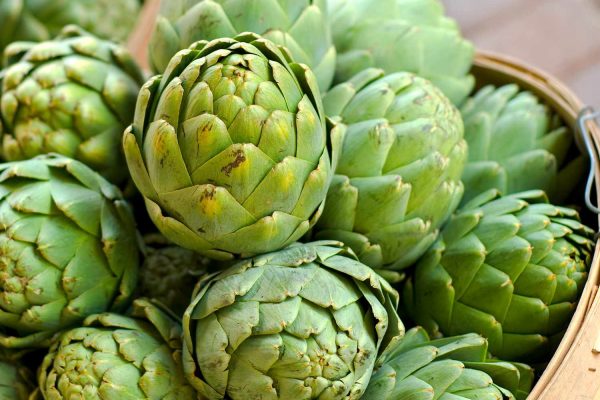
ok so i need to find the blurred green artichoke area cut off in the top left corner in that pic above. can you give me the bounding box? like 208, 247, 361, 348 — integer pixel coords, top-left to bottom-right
0, 0, 140, 53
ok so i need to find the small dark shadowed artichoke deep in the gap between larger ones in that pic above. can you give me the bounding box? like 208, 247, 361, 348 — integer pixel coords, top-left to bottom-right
140, 235, 211, 315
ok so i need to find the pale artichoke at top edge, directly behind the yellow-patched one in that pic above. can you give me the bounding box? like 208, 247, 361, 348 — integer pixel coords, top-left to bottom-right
149, 0, 335, 90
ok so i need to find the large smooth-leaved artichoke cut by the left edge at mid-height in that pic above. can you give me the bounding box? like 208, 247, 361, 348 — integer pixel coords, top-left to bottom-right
0, 156, 139, 348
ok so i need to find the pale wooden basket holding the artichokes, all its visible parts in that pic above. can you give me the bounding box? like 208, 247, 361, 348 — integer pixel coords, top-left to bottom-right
129, 0, 600, 400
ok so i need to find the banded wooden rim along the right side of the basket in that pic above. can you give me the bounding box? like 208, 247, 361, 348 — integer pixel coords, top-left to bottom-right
472, 51, 600, 400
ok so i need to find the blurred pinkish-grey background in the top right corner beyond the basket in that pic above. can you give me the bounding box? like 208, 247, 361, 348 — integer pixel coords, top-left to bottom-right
442, 0, 600, 109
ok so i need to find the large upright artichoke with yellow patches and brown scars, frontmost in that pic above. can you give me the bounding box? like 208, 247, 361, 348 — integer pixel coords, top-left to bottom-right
123, 34, 343, 259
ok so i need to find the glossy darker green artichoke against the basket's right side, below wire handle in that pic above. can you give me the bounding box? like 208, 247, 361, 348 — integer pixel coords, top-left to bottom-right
402, 190, 594, 362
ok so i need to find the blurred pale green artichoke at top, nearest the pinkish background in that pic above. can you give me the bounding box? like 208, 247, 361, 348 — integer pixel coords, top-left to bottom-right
329, 0, 475, 104
